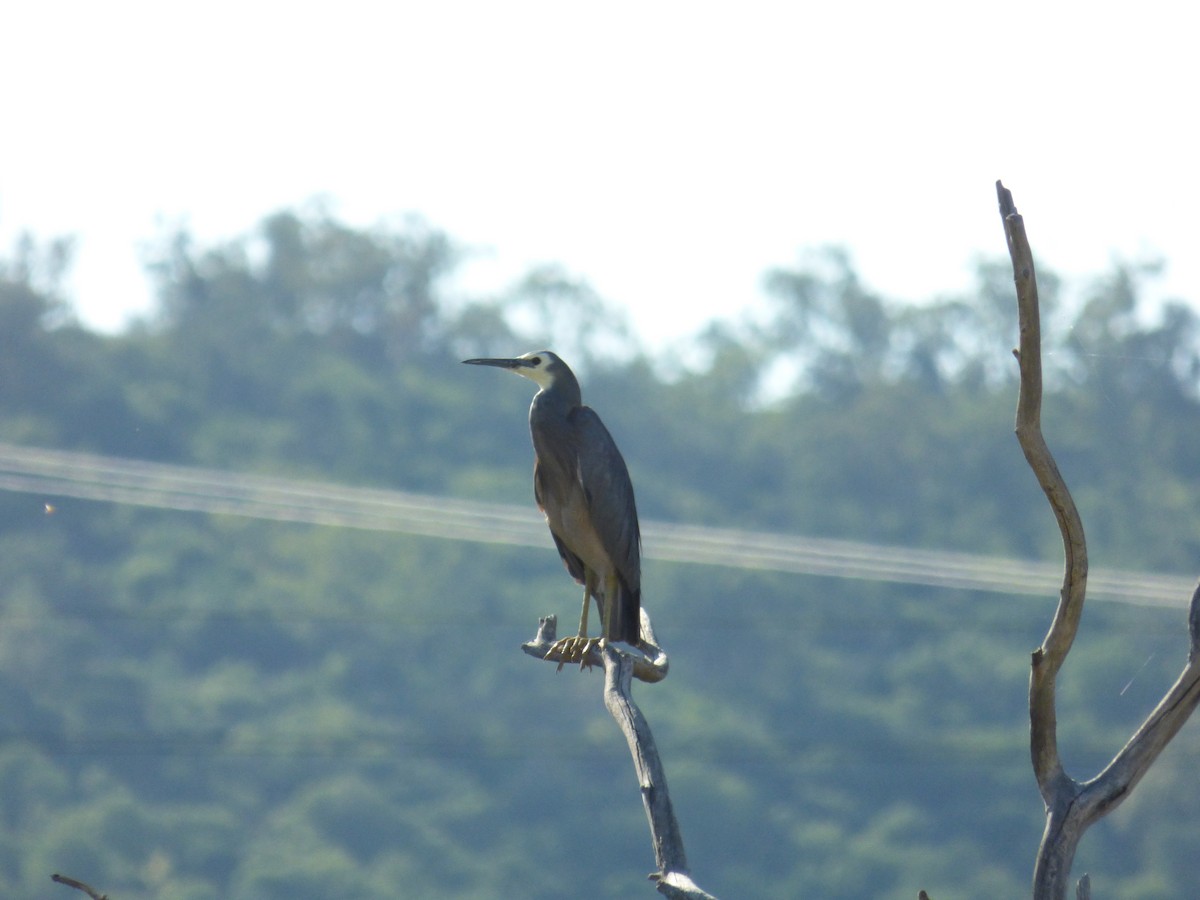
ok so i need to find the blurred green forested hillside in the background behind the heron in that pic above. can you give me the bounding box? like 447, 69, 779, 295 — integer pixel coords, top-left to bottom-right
0, 209, 1200, 900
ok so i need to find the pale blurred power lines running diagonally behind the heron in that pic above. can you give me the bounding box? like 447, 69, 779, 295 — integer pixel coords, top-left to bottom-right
0, 443, 1195, 608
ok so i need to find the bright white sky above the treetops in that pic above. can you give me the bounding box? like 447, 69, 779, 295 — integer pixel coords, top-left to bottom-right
0, 0, 1200, 349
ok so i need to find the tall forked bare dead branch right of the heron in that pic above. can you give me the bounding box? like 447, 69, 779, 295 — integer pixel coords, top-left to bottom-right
996, 181, 1200, 900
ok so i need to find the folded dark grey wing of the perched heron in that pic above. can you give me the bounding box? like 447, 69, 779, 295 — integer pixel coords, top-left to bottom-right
570, 407, 642, 594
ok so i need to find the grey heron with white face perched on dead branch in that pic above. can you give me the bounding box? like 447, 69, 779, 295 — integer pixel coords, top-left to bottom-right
463, 350, 642, 668
